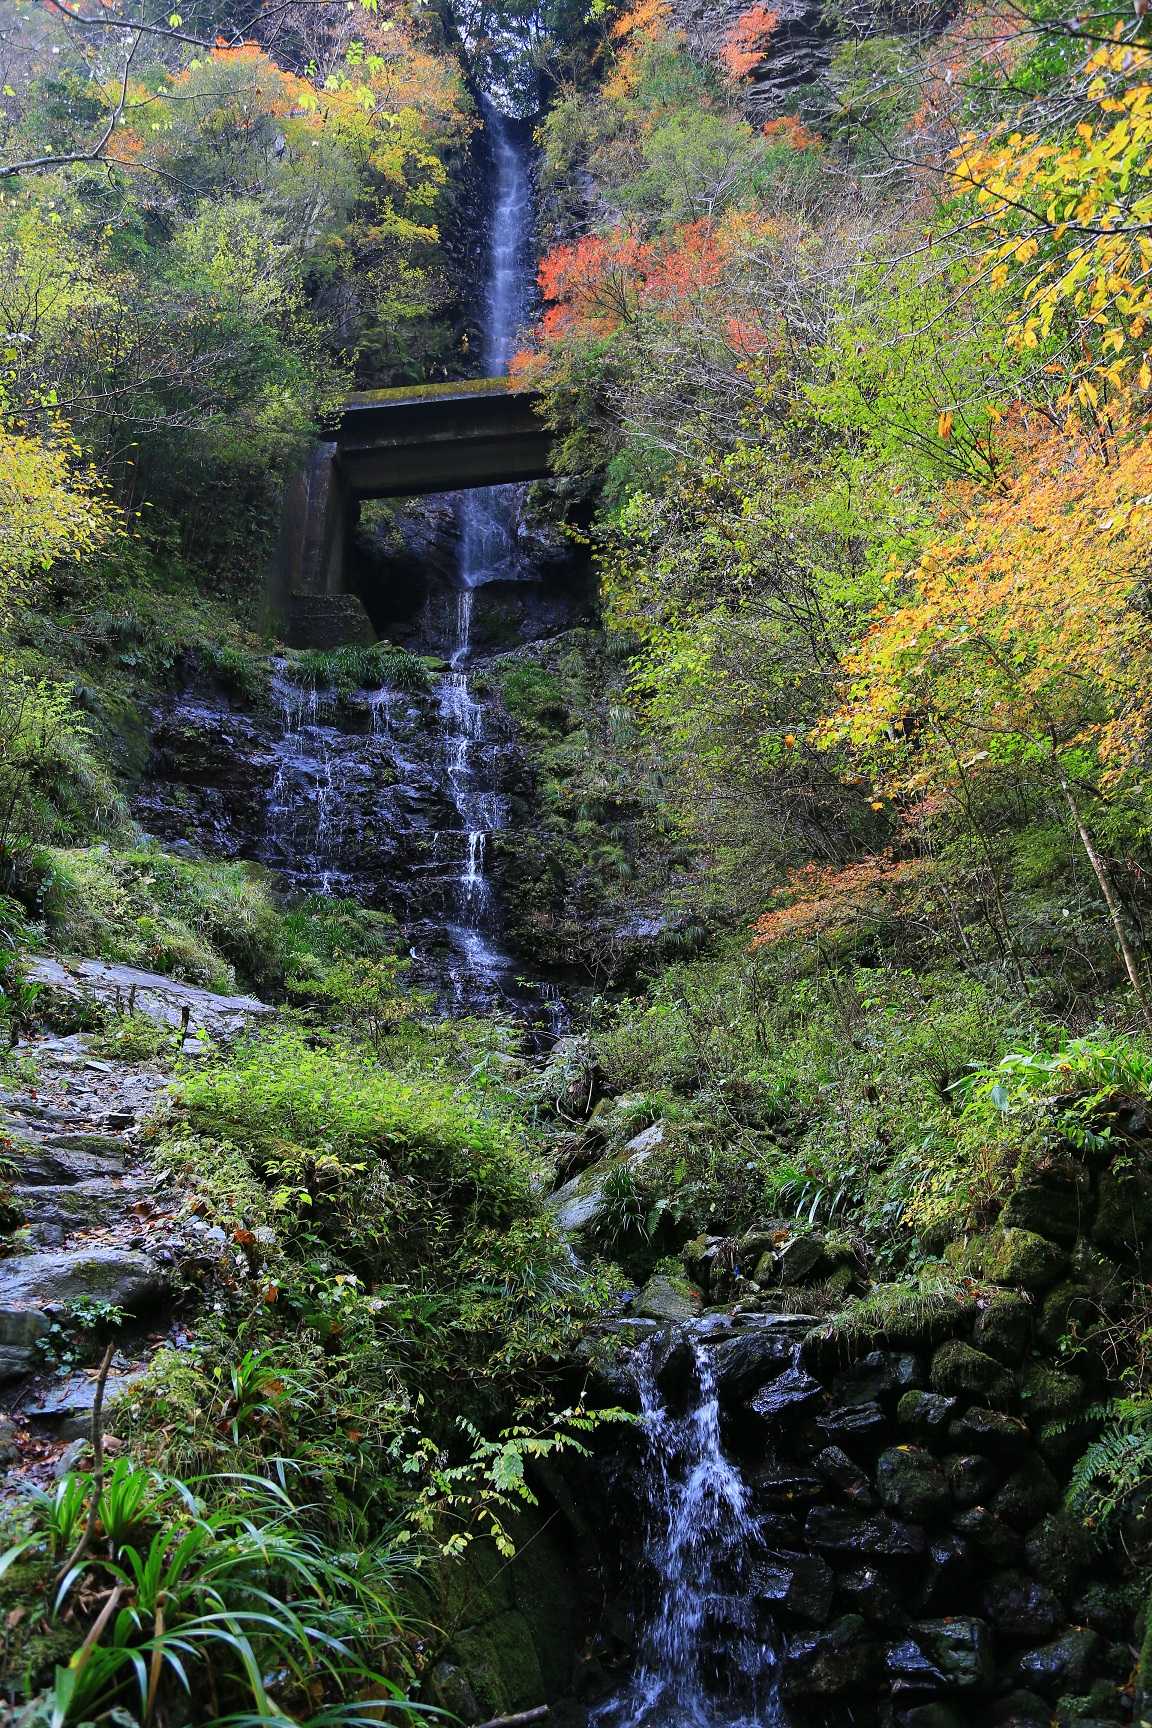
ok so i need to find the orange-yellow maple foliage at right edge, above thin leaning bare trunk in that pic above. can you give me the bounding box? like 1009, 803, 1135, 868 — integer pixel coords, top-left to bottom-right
817, 400, 1152, 788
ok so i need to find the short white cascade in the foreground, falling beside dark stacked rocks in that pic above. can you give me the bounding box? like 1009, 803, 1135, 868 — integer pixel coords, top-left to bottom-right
594, 1337, 784, 1728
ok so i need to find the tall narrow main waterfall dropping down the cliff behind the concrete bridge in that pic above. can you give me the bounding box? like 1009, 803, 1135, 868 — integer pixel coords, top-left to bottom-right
440, 107, 532, 999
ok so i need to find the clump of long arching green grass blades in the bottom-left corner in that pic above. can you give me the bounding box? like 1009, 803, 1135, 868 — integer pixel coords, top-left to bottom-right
0, 1458, 419, 1728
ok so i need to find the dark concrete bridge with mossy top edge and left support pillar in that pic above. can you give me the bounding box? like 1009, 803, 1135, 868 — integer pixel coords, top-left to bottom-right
275, 378, 551, 628
